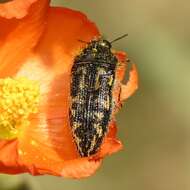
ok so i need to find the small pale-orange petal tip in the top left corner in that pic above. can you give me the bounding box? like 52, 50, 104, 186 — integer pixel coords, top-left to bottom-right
0, 0, 37, 19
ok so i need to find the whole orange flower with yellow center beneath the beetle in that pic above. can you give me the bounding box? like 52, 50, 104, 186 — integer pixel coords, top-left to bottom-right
0, 0, 138, 178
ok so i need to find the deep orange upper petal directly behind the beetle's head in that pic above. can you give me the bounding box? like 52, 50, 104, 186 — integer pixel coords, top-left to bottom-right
37, 8, 99, 68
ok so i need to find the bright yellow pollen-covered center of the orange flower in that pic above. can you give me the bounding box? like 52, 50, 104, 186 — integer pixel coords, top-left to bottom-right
0, 77, 40, 140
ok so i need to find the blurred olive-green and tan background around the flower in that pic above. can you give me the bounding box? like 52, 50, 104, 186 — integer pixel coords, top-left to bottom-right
0, 0, 190, 190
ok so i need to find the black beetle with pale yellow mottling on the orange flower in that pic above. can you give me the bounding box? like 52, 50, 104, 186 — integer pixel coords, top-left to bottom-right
69, 35, 126, 157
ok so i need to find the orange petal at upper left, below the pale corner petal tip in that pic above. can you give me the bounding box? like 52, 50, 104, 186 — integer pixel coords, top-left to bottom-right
0, 0, 49, 78
